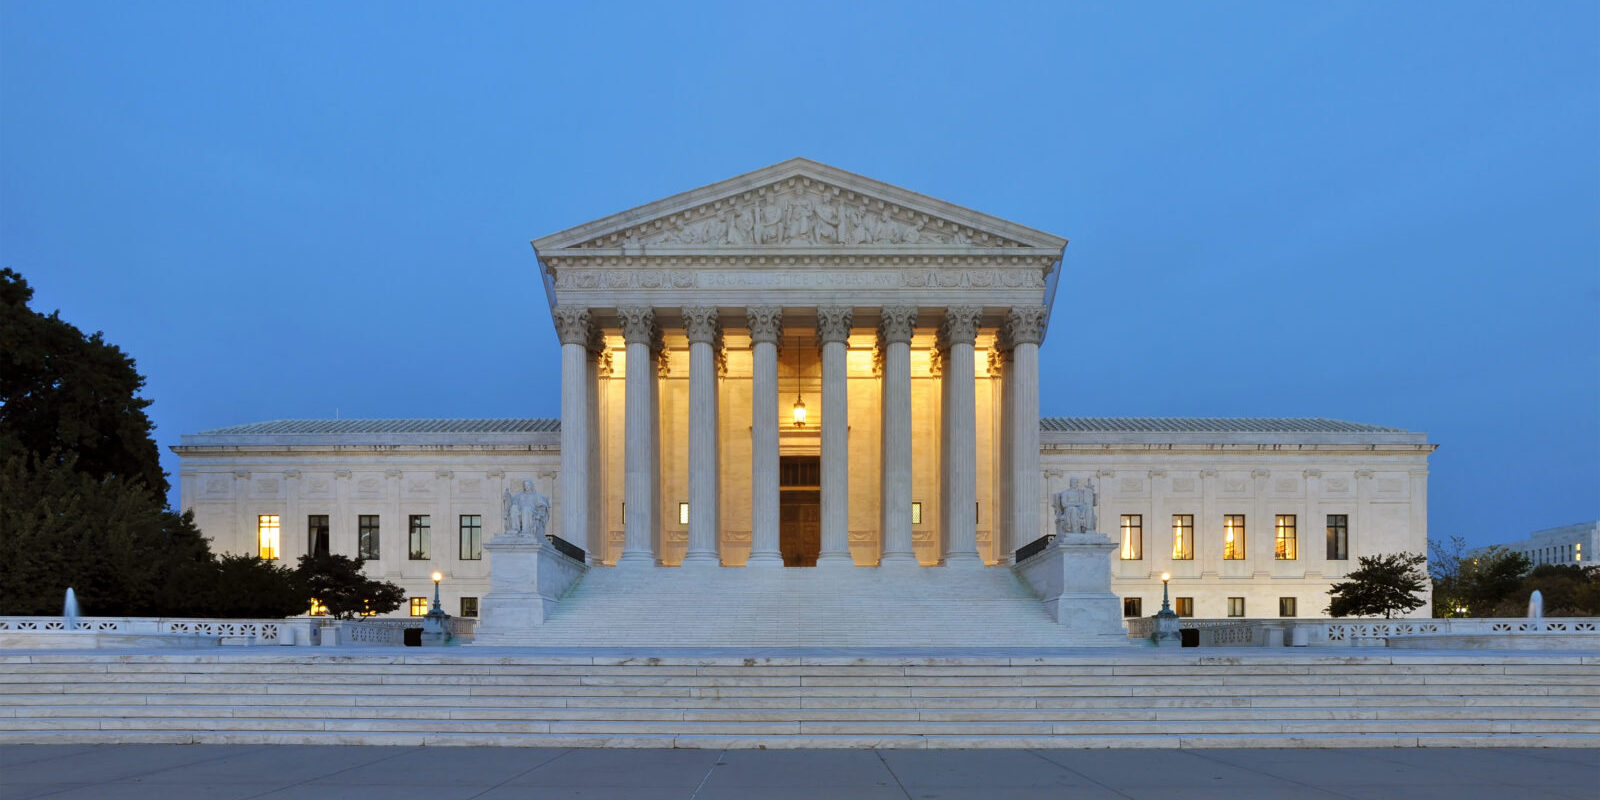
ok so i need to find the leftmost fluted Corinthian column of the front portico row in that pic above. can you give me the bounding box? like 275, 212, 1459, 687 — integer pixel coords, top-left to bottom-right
550, 306, 594, 547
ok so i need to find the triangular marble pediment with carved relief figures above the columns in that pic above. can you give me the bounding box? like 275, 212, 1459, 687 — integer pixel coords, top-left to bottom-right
533, 158, 1067, 254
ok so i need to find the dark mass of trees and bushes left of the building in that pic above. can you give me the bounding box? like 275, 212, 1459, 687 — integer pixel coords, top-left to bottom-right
0, 269, 310, 618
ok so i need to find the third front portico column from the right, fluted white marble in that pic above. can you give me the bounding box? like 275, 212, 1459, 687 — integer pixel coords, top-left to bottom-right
878, 306, 917, 566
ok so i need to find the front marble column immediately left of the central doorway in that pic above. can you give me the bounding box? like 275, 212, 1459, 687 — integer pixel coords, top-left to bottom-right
744, 306, 784, 566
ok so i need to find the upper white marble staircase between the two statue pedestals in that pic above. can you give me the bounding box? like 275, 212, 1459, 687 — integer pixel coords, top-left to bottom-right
530, 566, 1066, 648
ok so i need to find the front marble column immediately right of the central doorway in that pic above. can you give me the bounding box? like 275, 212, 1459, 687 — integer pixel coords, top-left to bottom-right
816, 306, 854, 566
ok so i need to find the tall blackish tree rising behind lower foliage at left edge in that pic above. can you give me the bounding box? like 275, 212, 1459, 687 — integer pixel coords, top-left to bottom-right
0, 269, 168, 498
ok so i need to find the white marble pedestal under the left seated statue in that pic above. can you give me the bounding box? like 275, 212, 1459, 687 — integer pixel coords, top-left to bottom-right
474, 536, 589, 646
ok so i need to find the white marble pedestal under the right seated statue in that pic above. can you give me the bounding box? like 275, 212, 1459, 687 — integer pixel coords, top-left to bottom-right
1013, 533, 1130, 646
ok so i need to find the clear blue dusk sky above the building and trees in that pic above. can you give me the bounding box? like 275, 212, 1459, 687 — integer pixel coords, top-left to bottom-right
0, 0, 1600, 544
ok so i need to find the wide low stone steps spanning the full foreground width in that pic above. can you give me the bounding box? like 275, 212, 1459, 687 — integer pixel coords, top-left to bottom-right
0, 649, 1600, 747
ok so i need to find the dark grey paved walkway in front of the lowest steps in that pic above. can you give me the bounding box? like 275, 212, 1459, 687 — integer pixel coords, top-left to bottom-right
0, 744, 1600, 800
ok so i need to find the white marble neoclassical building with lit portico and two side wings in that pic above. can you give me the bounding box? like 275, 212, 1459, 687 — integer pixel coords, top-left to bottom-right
174, 158, 1434, 640
